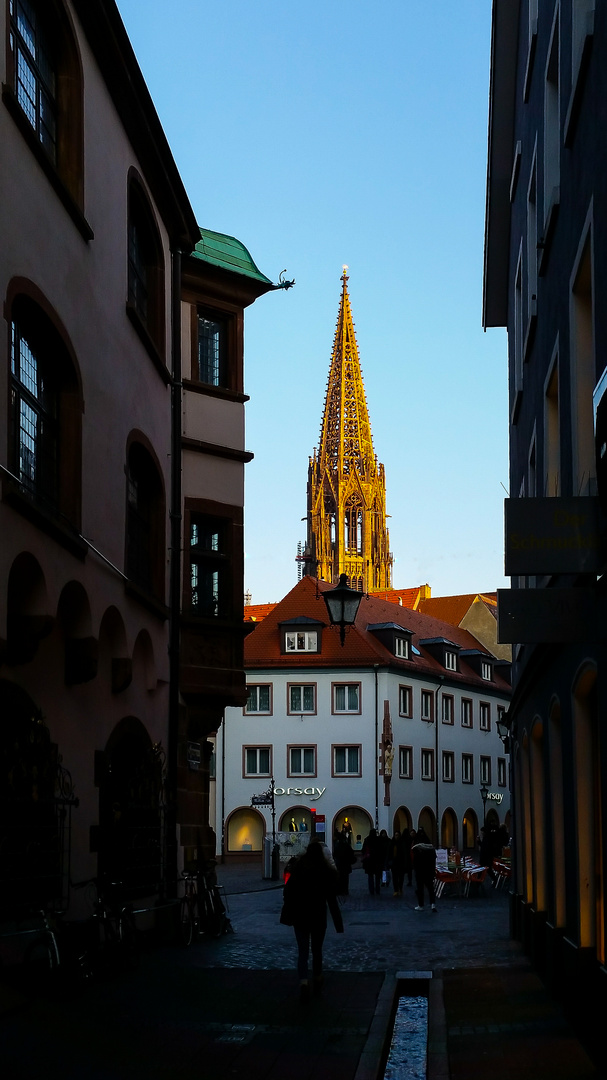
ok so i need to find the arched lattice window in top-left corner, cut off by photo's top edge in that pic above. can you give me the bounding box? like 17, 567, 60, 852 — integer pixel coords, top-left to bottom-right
3, 0, 85, 212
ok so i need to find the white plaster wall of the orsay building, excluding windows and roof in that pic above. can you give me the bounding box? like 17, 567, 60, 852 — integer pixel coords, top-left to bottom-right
216, 670, 510, 845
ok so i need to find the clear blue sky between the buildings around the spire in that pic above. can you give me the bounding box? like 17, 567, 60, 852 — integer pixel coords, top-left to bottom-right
118, 0, 508, 604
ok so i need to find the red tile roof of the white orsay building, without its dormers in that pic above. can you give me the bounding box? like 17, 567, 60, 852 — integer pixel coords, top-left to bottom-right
244, 577, 510, 693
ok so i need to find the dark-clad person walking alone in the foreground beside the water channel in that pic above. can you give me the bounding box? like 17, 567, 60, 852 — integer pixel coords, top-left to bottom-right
281, 840, 343, 1001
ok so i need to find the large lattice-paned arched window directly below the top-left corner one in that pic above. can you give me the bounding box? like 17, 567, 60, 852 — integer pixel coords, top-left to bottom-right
9, 285, 82, 528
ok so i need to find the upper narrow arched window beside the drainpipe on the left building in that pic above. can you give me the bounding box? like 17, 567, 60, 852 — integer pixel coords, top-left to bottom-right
126, 178, 165, 357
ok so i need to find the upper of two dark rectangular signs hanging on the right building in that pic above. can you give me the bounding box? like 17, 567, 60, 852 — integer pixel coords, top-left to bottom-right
504, 496, 604, 577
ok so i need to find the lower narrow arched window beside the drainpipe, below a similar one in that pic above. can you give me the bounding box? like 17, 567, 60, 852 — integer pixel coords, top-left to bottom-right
126, 442, 164, 599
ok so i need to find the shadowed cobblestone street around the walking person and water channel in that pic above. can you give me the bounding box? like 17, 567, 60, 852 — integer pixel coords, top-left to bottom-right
0, 866, 598, 1080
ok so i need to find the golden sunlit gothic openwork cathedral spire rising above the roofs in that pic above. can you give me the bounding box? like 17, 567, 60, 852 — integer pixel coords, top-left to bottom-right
305, 267, 392, 593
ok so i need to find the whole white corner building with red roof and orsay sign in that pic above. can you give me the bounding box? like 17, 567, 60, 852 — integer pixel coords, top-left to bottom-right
215, 578, 510, 859
